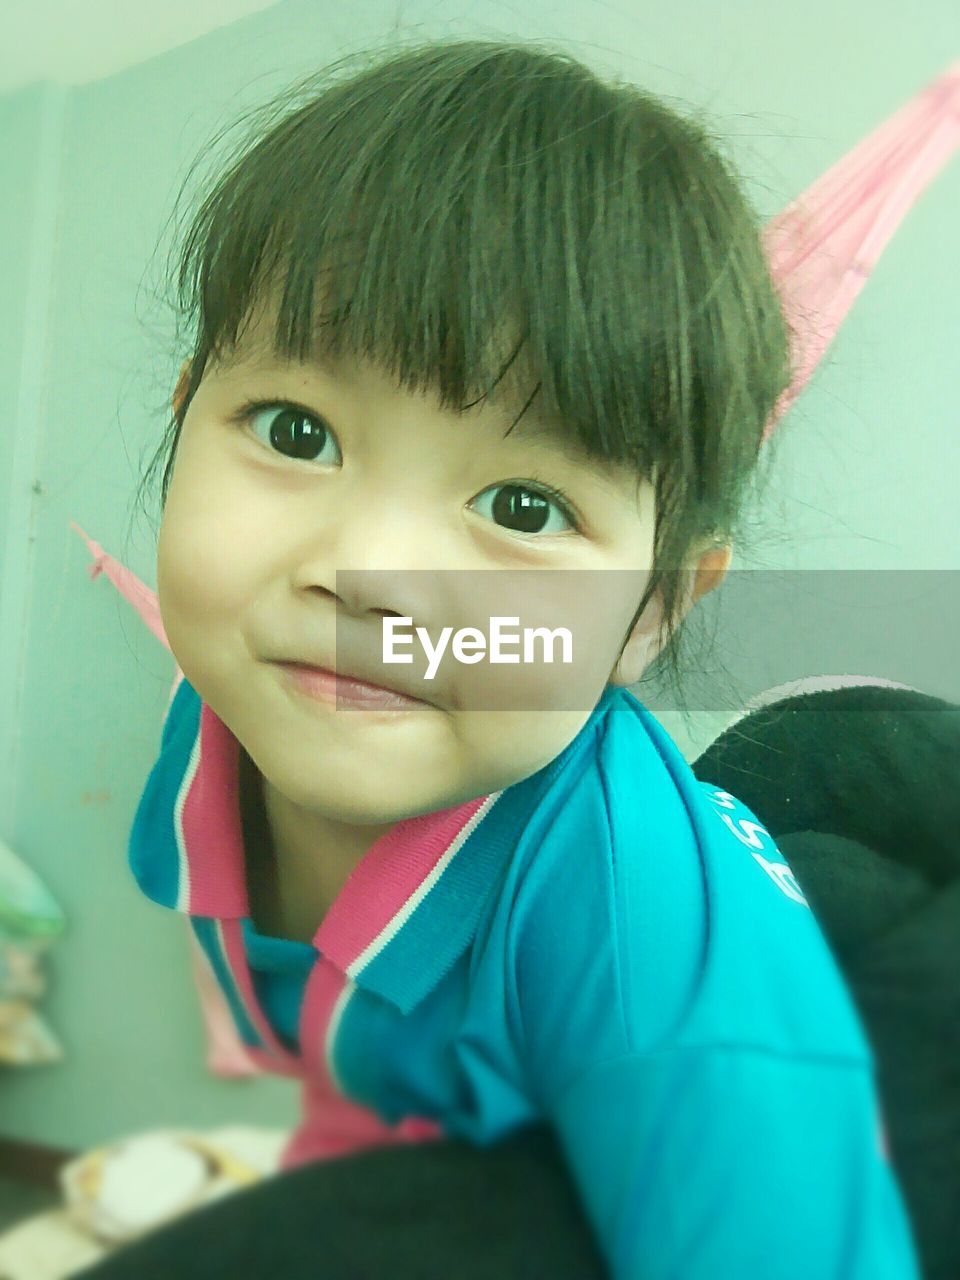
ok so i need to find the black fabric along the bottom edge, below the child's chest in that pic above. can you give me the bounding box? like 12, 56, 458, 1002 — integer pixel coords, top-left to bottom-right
77, 1126, 608, 1280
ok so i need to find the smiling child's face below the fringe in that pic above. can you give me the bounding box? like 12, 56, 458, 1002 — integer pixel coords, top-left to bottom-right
157, 294, 722, 824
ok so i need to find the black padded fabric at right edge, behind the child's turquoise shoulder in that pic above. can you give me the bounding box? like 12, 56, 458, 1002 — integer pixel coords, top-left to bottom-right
694, 686, 960, 1280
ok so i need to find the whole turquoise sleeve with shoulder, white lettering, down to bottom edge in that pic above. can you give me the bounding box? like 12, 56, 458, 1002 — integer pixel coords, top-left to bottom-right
511, 709, 918, 1280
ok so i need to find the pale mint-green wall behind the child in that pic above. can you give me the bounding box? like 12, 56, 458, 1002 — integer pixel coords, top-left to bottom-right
0, 0, 960, 1147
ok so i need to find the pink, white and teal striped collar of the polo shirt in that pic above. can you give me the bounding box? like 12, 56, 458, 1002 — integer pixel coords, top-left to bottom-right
129, 677, 616, 1012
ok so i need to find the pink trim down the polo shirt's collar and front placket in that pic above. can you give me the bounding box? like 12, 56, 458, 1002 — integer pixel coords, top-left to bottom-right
163, 686, 471, 1167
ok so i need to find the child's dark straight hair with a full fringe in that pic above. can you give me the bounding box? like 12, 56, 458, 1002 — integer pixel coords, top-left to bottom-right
141, 40, 791, 727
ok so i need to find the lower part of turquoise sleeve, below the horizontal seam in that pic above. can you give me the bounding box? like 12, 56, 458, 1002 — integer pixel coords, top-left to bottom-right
548, 1047, 919, 1280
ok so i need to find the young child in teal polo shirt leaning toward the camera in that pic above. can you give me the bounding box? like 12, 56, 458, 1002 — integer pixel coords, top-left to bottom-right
122, 42, 916, 1280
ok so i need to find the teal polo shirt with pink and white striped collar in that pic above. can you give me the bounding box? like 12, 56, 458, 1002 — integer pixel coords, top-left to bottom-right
124, 680, 918, 1280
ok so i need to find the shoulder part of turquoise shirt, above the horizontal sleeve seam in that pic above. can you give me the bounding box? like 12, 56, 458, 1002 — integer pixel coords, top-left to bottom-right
509, 690, 869, 1061
